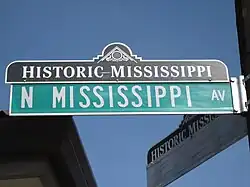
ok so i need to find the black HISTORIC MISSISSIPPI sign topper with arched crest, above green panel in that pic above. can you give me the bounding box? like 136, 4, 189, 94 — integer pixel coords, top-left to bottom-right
5, 42, 229, 84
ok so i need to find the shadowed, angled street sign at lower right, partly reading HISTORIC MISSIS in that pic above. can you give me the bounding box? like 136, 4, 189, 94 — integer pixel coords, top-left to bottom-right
147, 114, 247, 187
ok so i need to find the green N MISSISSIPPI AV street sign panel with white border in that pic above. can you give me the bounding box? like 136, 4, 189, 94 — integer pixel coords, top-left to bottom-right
10, 82, 234, 116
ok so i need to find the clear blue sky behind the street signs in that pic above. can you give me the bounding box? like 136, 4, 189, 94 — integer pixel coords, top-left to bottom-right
0, 0, 250, 187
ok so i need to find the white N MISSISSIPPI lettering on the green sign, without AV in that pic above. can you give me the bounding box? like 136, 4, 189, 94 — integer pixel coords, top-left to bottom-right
20, 84, 192, 109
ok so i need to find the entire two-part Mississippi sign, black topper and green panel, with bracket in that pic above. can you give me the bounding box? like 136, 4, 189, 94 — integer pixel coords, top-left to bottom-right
5, 42, 246, 115
